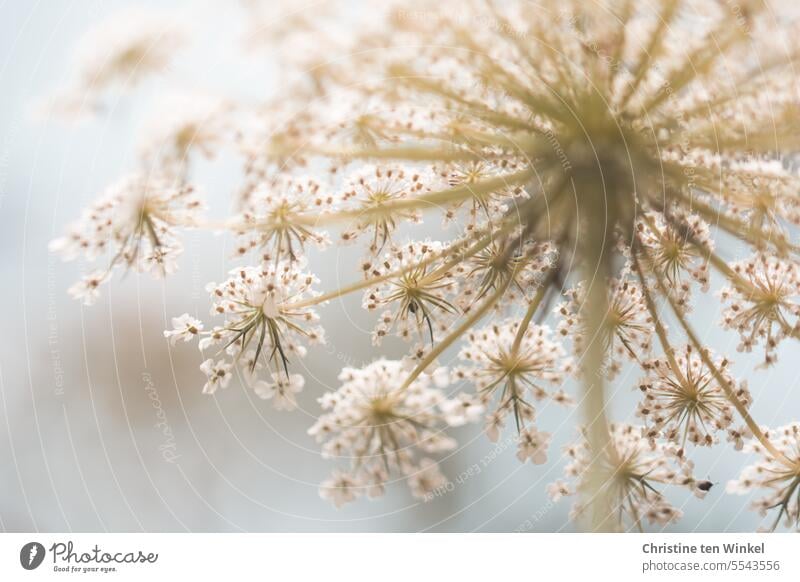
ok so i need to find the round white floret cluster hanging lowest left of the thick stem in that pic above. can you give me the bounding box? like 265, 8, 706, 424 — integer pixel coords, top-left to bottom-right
309, 359, 472, 505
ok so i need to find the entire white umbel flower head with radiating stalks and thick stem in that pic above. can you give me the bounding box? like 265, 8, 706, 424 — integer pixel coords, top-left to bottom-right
45, 0, 800, 530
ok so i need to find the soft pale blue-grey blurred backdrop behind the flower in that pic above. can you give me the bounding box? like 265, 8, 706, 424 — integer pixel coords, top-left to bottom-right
0, 0, 800, 532
